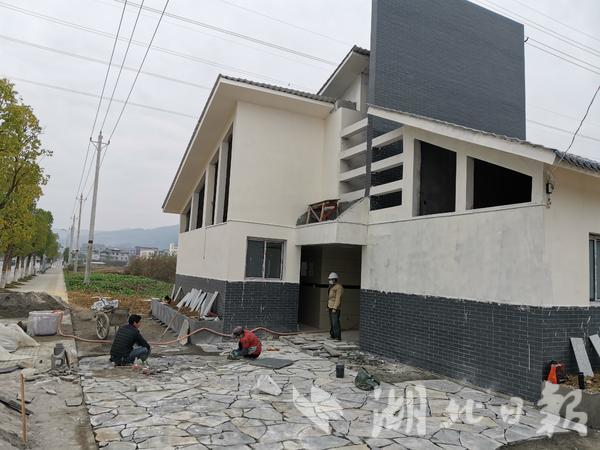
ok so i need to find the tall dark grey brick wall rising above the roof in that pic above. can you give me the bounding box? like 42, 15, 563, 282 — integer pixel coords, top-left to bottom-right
369, 0, 525, 139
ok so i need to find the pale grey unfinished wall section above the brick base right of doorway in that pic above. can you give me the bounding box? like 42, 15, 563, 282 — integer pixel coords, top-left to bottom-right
362, 206, 552, 305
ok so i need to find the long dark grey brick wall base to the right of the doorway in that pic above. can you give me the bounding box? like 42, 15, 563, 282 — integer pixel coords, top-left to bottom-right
360, 290, 600, 400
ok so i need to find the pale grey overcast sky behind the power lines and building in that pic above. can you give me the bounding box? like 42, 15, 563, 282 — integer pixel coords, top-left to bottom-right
0, 0, 600, 230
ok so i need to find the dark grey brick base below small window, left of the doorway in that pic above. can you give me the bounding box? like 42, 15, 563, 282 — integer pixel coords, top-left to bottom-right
175, 275, 300, 332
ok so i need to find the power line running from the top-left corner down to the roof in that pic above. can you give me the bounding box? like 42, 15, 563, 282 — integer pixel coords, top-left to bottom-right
0, 2, 310, 90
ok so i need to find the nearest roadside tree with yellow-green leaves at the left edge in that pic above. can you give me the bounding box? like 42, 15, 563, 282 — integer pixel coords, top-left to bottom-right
0, 79, 52, 287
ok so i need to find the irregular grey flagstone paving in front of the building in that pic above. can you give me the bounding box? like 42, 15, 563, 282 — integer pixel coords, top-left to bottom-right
80, 341, 573, 450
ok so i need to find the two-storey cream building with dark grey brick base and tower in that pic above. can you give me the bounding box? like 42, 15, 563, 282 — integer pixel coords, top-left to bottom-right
163, 0, 600, 399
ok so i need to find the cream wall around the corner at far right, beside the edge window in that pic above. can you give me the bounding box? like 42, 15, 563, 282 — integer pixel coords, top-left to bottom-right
545, 168, 600, 305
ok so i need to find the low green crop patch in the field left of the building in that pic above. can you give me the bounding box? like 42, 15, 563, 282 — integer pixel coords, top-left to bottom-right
65, 271, 172, 298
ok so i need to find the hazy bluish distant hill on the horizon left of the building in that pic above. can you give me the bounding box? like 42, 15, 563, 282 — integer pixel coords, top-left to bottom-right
54, 225, 179, 250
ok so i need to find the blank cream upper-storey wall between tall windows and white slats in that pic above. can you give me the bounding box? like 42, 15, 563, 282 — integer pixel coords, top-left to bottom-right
229, 102, 325, 225
